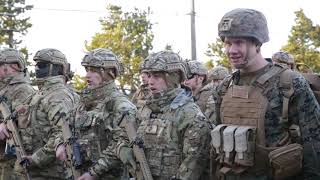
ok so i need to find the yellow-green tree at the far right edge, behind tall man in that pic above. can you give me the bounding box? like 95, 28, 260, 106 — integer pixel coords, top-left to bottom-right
281, 9, 320, 72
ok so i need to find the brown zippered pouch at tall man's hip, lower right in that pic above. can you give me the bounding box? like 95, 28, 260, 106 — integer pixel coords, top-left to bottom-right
269, 143, 303, 180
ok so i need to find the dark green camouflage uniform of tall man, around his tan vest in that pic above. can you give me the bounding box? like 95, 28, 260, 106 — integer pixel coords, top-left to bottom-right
214, 64, 320, 180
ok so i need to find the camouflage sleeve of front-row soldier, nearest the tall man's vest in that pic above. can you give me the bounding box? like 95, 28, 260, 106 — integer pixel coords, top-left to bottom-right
177, 104, 209, 180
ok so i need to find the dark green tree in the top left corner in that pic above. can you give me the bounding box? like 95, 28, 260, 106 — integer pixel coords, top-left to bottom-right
0, 0, 33, 48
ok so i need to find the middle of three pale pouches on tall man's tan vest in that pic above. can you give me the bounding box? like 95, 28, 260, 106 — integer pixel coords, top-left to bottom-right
223, 126, 238, 165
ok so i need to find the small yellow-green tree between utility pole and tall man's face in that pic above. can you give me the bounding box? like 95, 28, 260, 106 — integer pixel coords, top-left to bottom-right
205, 38, 231, 69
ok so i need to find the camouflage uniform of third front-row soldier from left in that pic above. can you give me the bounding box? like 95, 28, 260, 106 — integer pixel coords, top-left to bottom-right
70, 81, 136, 179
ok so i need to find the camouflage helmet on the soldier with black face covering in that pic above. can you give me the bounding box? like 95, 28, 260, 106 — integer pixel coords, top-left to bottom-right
33, 48, 70, 75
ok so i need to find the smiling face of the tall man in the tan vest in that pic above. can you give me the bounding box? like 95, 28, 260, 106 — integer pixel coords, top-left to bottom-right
224, 37, 257, 69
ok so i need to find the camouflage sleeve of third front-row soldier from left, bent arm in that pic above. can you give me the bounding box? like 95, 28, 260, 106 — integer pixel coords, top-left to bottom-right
90, 97, 137, 177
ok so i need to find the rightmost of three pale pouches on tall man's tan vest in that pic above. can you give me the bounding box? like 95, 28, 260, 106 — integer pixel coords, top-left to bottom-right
235, 126, 256, 167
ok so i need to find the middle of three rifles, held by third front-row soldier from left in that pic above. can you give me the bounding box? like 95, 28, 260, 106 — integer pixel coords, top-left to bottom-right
60, 113, 82, 180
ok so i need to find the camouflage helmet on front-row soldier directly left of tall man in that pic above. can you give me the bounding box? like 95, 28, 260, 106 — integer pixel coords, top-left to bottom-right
140, 51, 187, 81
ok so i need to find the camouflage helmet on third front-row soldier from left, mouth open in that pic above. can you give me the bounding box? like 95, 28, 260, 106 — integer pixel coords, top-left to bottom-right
81, 48, 123, 76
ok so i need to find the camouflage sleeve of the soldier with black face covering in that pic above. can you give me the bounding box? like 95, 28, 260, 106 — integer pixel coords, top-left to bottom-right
32, 91, 73, 165
